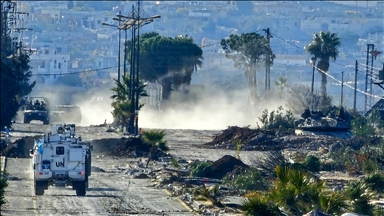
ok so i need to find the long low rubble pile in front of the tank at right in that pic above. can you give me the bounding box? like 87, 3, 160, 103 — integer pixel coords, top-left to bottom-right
202, 126, 341, 151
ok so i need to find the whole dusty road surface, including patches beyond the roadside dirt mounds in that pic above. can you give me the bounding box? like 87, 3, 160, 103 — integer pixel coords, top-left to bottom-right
2, 123, 258, 216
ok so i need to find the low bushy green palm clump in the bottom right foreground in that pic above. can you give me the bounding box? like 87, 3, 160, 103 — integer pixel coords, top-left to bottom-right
242, 165, 348, 215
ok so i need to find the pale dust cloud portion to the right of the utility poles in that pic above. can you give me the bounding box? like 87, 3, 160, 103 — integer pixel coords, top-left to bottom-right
139, 89, 282, 130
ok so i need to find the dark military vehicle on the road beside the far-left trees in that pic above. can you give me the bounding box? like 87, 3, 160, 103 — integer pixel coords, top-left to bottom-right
23, 97, 50, 125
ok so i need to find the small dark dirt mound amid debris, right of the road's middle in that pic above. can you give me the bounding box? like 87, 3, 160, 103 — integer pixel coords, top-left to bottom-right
207, 155, 248, 179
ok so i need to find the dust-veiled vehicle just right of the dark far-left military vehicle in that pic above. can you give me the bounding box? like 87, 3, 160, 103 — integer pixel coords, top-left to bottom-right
51, 105, 81, 123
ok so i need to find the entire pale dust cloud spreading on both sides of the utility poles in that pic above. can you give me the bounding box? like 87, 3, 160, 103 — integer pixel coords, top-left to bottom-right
31, 83, 283, 130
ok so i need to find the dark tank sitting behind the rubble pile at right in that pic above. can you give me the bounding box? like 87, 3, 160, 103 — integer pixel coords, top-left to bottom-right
295, 109, 351, 132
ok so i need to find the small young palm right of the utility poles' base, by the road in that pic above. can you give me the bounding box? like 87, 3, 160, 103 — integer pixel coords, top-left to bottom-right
143, 130, 169, 167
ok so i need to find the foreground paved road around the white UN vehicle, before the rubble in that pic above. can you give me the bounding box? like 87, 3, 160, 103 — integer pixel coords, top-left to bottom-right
1, 158, 191, 216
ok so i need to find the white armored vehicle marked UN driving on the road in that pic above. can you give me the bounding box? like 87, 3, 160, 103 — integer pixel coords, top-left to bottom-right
30, 124, 93, 196
